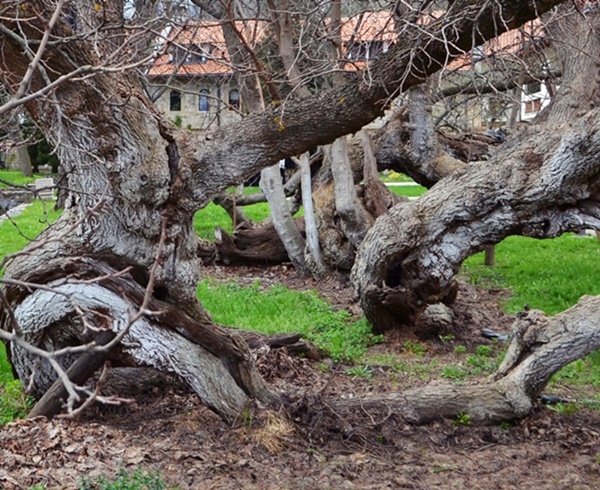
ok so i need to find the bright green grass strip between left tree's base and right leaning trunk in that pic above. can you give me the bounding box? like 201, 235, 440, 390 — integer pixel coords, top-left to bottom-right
198, 280, 380, 360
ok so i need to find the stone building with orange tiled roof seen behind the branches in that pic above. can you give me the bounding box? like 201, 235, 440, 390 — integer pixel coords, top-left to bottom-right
147, 11, 550, 129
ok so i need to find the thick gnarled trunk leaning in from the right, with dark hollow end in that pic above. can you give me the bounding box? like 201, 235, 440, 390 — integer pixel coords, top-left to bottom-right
352, 3, 600, 332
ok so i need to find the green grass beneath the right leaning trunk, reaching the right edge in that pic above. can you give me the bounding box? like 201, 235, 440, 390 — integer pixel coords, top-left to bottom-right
462, 233, 600, 315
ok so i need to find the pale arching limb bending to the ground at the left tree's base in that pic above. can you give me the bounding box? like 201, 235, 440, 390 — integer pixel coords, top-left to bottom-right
7, 258, 276, 419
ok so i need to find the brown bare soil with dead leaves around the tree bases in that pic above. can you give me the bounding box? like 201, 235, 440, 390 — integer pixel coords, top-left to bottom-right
0, 266, 600, 490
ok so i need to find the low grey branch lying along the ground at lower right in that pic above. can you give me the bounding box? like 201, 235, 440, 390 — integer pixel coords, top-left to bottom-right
332, 296, 600, 424
